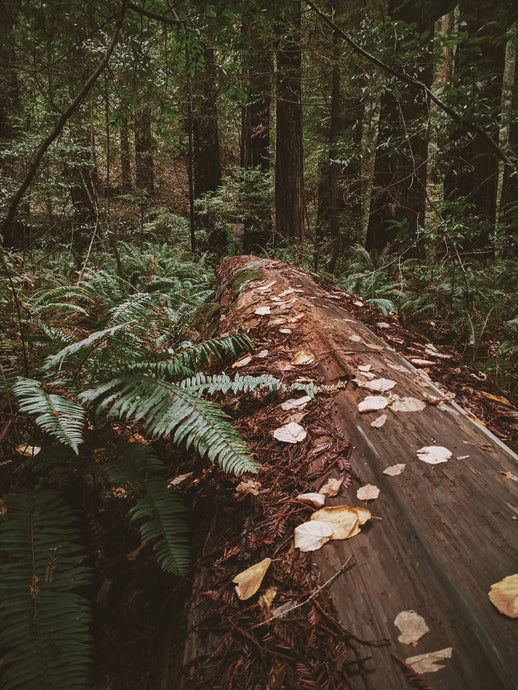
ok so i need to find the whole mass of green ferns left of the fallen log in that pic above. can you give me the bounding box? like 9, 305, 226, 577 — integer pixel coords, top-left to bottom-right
0, 246, 292, 689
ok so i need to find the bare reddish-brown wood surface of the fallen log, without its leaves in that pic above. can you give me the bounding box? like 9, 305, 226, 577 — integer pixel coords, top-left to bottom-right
183, 257, 518, 690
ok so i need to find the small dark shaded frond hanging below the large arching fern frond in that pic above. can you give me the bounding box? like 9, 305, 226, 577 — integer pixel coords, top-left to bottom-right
130, 481, 189, 575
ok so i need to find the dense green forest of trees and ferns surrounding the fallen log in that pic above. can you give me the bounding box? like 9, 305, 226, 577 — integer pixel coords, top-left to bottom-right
0, 0, 518, 688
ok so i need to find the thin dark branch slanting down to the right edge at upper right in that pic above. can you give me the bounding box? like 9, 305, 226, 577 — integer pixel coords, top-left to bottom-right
304, 0, 518, 174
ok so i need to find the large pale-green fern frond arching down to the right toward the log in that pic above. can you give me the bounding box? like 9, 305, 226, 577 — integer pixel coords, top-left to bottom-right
80, 375, 257, 474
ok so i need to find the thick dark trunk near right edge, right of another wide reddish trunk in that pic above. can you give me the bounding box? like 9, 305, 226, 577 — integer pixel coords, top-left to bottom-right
444, 0, 505, 248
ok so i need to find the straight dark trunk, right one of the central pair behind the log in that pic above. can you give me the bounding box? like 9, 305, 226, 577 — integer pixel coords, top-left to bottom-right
275, 0, 304, 241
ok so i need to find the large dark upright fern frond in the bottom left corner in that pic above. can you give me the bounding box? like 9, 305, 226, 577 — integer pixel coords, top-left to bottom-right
0, 490, 91, 690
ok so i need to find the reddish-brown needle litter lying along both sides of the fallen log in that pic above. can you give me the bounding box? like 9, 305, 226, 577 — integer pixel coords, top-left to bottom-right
90, 257, 518, 690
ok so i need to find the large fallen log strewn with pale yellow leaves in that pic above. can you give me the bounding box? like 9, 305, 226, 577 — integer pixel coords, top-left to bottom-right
180, 257, 518, 690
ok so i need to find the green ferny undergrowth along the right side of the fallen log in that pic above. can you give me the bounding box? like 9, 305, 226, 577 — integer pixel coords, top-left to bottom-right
337, 247, 518, 393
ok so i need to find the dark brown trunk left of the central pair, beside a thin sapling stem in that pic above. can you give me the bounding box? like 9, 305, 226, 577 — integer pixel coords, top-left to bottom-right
192, 48, 221, 198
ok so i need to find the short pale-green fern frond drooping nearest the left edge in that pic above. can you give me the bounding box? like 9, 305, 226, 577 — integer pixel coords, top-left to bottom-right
13, 376, 85, 453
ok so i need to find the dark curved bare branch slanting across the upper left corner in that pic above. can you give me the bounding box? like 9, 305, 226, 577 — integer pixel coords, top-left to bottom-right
2, 0, 128, 235
